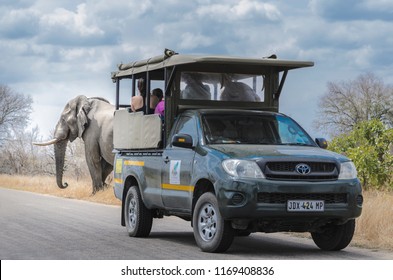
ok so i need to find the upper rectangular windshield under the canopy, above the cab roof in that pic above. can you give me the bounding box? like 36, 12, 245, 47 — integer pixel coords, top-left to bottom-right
180, 72, 264, 102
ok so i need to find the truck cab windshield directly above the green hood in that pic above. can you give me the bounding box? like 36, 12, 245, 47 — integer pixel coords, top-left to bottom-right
202, 114, 315, 146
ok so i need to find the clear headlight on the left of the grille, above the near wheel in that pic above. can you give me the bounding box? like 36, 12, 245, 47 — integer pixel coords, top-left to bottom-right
222, 159, 265, 179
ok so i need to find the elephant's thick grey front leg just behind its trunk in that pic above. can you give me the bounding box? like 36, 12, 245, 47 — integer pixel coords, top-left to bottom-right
85, 145, 103, 194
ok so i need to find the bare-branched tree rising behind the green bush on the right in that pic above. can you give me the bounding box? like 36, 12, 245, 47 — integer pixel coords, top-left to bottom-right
314, 73, 393, 136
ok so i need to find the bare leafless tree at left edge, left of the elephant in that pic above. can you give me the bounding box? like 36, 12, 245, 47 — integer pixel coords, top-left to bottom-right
0, 84, 33, 144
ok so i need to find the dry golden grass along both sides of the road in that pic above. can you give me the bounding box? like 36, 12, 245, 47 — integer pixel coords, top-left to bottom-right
0, 174, 393, 250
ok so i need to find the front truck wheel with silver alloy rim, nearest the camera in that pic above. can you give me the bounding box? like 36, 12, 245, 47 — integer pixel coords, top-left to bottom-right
192, 192, 235, 253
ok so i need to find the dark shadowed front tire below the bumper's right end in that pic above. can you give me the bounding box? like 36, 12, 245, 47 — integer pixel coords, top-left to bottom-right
311, 220, 355, 251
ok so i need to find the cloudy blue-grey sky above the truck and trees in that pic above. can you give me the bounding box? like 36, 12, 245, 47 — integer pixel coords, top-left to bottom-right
0, 0, 393, 139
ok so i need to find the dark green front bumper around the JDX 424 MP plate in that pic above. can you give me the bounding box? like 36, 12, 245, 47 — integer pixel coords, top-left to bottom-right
215, 179, 363, 232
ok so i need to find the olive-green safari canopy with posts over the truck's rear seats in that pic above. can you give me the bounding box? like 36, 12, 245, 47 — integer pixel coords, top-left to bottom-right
112, 49, 314, 148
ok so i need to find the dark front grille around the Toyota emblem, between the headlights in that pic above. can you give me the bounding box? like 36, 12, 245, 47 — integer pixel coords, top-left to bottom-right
258, 160, 339, 181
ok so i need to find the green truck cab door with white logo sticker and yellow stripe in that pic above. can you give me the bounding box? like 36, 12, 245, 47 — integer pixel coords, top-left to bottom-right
161, 116, 198, 211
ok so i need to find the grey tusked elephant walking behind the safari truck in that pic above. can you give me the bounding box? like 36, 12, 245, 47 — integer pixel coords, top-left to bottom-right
33, 95, 115, 195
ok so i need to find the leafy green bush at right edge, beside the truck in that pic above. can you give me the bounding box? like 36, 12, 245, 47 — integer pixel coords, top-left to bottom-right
329, 120, 393, 189
